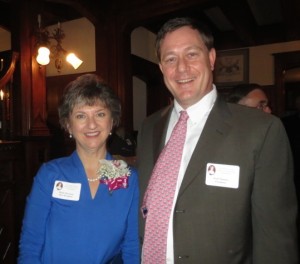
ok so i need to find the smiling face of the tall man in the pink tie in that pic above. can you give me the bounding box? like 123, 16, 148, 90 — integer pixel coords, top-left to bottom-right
159, 26, 216, 109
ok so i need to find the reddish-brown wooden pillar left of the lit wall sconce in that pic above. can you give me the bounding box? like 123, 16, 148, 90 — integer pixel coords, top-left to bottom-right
12, 0, 49, 136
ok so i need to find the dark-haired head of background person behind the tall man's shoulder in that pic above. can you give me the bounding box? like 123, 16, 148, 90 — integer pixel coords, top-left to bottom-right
227, 83, 272, 114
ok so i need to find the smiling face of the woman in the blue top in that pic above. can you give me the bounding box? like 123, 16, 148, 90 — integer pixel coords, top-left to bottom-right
68, 100, 113, 155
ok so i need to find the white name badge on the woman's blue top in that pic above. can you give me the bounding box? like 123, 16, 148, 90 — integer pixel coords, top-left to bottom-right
52, 181, 81, 201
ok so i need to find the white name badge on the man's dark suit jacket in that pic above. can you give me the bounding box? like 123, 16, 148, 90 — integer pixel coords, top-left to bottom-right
205, 163, 240, 189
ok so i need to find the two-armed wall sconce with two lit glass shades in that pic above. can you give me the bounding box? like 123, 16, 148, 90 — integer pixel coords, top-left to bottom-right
36, 15, 83, 73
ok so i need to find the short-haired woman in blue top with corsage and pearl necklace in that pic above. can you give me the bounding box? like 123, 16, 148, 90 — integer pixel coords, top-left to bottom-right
18, 74, 140, 264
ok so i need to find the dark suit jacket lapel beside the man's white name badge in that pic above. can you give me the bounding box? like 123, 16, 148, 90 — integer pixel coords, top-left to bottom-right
179, 97, 231, 196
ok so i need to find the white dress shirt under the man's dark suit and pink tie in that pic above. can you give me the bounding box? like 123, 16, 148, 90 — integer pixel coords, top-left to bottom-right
166, 85, 217, 264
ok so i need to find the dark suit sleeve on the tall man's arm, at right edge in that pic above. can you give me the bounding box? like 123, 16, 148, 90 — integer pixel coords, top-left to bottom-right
252, 119, 298, 264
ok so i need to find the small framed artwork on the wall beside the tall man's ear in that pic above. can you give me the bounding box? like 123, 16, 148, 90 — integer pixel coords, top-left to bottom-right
214, 49, 249, 86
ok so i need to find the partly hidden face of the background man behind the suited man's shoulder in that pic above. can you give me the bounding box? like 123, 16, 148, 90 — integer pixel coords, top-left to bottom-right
238, 89, 271, 114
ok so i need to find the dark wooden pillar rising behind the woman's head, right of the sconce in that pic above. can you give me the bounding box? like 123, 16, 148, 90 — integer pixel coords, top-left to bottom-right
95, 16, 133, 130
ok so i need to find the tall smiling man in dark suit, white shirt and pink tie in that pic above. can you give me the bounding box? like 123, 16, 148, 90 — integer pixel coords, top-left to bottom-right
137, 18, 297, 264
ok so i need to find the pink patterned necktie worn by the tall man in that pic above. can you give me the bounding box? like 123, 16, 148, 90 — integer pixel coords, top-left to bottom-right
142, 111, 189, 264
